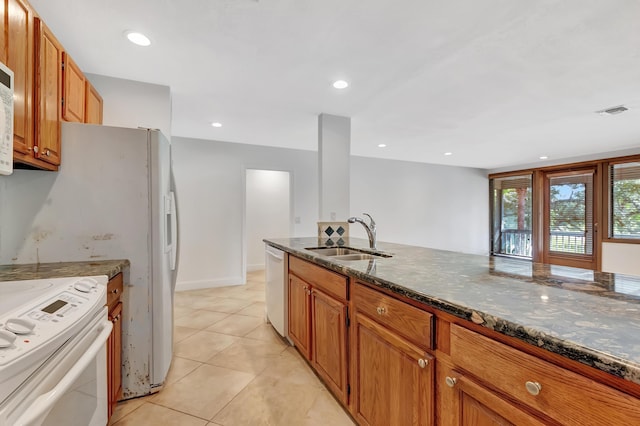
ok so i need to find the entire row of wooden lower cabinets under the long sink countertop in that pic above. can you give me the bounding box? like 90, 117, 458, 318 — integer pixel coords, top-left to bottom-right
289, 253, 640, 426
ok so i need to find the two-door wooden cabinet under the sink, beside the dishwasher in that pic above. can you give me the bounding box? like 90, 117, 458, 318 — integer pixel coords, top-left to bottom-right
289, 257, 349, 405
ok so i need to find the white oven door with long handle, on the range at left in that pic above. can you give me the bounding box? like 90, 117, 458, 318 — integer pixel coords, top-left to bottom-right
0, 307, 113, 426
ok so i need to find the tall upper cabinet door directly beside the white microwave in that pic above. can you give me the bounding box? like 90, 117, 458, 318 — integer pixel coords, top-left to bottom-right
6, 0, 35, 157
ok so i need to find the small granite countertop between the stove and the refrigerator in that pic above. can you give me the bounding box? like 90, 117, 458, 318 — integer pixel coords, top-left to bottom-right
0, 259, 129, 281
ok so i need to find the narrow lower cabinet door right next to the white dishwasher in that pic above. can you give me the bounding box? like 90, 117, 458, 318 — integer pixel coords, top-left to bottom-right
289, 275, 311, 360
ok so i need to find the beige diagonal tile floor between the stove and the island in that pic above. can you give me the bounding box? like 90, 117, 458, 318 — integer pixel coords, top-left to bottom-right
111, 271, 354, 426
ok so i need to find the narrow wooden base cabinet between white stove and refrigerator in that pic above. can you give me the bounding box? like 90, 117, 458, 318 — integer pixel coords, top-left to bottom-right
107, 273, 123, 418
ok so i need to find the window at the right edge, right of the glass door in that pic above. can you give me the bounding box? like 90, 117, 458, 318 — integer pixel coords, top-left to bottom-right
609, 162, 640, 239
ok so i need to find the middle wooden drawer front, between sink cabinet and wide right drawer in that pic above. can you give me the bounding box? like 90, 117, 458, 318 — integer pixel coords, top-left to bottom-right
351, 284, 433, 349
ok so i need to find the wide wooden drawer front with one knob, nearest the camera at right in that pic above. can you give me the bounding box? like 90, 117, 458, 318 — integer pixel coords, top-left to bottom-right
451, 325, 640, 425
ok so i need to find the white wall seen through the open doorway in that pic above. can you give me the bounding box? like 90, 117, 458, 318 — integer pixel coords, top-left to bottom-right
245, 169, 291, 272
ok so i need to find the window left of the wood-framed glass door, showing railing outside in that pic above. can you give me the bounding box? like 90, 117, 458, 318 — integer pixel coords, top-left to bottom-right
490, 175, 531, 258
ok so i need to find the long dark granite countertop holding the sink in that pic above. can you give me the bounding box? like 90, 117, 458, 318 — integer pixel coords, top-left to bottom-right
264, 237, 640, 384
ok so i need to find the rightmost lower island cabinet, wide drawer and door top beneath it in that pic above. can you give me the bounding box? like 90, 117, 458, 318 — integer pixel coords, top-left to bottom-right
450, 325, 640, 425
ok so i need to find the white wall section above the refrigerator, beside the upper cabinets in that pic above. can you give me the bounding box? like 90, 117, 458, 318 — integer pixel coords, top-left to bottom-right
86, 74, 171, 140
